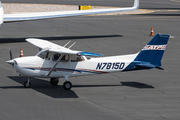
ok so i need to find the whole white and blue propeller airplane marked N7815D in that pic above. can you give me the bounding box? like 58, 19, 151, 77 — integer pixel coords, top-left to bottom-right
6, 34, 170, 90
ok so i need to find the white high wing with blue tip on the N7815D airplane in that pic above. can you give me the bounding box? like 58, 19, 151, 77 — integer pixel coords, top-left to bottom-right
26, 38, 101, 56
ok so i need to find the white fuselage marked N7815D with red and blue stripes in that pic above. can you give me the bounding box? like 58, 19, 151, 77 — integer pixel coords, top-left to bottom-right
14, 54, 137, 78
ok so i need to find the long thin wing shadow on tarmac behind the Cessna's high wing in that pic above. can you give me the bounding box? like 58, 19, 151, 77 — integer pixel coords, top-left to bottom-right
0, 35, 123, 43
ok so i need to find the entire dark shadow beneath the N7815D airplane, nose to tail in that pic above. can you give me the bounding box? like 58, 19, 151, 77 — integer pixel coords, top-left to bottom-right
0, 76, 154, 98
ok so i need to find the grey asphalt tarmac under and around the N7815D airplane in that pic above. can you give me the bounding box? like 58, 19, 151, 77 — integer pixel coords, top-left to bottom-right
0, 1, 180, 120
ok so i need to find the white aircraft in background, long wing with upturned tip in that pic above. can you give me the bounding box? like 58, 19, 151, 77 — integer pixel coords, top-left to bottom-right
0, 0, 139, 25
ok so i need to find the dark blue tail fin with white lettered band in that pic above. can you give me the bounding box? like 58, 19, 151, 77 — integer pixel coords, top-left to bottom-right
134, 34, 170, 68
